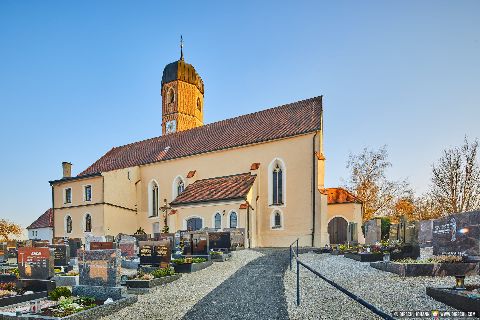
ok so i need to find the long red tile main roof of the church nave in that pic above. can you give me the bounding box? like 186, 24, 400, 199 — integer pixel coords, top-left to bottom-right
79, 96, 322, 176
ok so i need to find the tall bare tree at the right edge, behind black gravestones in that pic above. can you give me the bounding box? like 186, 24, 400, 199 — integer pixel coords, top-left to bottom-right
430, 137, 480, 215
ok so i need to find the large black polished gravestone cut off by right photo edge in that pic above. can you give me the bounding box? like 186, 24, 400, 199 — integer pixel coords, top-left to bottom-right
432, 211, 480, 258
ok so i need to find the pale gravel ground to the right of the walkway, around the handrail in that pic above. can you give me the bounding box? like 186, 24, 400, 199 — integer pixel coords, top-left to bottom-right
284, 253, 480, 319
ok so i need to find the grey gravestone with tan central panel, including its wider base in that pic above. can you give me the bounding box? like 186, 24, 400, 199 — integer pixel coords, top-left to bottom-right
72, 249, 126, 300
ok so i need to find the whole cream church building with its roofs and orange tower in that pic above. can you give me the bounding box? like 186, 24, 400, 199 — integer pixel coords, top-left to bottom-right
50, 50, 361, 247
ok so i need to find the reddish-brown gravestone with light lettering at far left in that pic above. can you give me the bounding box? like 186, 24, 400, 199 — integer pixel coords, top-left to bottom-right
17, 247, 54, 280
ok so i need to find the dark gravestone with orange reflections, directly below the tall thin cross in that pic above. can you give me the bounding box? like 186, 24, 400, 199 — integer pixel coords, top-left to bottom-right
138, 240, 172, 267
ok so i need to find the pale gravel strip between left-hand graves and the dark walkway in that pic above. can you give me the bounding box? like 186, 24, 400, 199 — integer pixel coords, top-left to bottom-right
102, 250, 263, 320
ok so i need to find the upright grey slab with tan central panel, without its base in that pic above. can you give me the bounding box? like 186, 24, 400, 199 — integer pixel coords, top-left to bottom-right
78, 249, 121, 287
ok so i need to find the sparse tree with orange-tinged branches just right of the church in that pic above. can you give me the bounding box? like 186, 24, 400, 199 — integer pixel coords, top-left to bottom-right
347, 146, 411, 221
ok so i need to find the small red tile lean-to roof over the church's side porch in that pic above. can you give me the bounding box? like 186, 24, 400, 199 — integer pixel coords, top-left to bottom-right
171, 173, 257, 206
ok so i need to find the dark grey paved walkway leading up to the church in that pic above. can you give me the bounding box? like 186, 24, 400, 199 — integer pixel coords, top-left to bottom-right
184, 249, 289, 320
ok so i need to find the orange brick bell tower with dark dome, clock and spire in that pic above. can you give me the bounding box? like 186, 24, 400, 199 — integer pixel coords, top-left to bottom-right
161, 37, 204, 135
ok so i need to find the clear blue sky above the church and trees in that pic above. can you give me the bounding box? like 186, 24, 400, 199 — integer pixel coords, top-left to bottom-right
0, 0, 480, 227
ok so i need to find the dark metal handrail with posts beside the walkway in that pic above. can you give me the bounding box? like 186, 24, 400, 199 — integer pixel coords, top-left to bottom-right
290, 239, 395, 320
